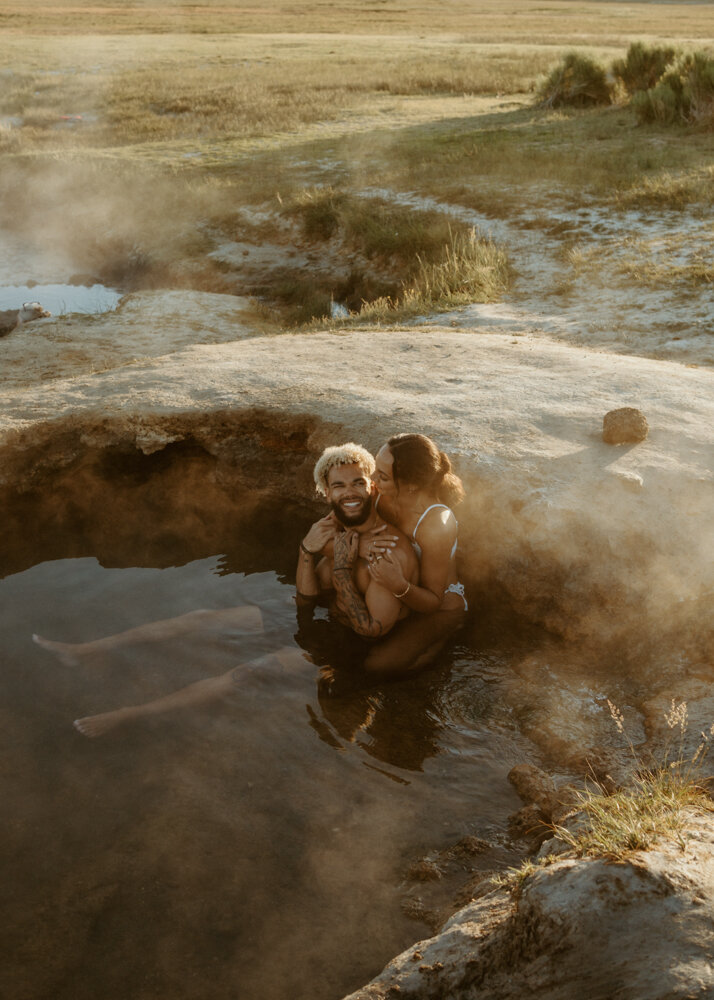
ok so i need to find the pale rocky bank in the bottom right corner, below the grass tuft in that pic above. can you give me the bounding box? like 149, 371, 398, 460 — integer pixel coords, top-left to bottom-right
347, 814, 714, 1000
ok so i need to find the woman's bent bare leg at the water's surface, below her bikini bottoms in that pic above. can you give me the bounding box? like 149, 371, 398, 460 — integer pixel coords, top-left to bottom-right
364, 611, 466, 676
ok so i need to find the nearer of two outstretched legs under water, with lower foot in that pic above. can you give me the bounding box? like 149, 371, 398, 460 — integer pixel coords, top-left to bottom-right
74, 646, 306, 737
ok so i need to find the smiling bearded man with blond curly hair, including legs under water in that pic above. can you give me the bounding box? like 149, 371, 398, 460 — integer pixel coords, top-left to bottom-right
33, 443, 419, 737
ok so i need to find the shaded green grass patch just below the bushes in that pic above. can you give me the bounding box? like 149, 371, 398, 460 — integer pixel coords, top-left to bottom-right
338, 100, 714, 210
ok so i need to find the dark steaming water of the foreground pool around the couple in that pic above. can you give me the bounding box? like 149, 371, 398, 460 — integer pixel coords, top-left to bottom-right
0, 540, 531, 1000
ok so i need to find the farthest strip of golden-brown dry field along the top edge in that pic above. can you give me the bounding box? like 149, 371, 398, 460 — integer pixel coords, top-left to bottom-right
5, 0, 712, 39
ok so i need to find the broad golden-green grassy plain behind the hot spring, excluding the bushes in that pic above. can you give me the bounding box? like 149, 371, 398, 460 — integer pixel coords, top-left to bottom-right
0, 0, 714, 321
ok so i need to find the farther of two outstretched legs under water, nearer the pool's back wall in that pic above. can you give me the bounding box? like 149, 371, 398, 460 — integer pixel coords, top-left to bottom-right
32, 604, 263, 666
